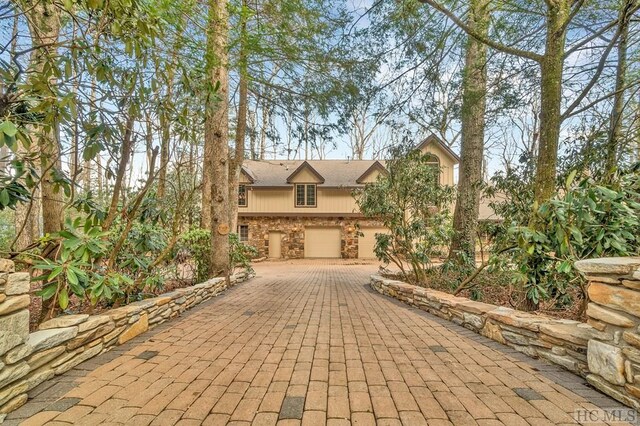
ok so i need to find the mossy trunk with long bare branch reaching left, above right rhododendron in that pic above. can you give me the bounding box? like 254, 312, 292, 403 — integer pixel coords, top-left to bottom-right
534, 0, 571, 204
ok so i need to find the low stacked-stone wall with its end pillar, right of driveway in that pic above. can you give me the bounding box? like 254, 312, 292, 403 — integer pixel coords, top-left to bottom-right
371, 258, 640, 410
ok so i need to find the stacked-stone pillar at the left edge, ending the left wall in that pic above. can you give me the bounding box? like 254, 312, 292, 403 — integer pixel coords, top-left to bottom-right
0, 259, 30, 422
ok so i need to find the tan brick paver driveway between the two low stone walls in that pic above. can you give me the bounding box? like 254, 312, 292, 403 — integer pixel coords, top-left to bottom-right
7, 262, 620, 426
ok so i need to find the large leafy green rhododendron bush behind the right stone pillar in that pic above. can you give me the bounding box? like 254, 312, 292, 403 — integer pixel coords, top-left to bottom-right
490, 166, 640, 304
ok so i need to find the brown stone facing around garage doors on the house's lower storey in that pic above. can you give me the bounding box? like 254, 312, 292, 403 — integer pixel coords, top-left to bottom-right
238, 216, 382, 259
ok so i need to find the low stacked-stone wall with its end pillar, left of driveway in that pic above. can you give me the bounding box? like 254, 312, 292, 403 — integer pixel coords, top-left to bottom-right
0, 259, 249, 423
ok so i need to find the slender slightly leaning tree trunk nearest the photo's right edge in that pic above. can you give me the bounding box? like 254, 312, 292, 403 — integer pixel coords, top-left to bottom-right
604, 0, 633, 180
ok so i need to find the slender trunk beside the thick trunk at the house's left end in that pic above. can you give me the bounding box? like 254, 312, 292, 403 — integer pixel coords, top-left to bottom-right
229, 0, 249, 232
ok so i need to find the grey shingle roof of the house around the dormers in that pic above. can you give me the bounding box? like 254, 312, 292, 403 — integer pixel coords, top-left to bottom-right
242, 160, 384, 187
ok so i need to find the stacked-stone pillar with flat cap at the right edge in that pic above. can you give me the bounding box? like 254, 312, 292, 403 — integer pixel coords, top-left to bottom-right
576, 257, 640, 409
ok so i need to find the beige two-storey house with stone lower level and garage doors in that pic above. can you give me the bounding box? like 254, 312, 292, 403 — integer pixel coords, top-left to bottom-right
238, 136, 459, 259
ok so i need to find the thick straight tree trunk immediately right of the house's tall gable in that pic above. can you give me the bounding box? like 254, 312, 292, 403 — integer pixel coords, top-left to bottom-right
449, 0, 489, 266
